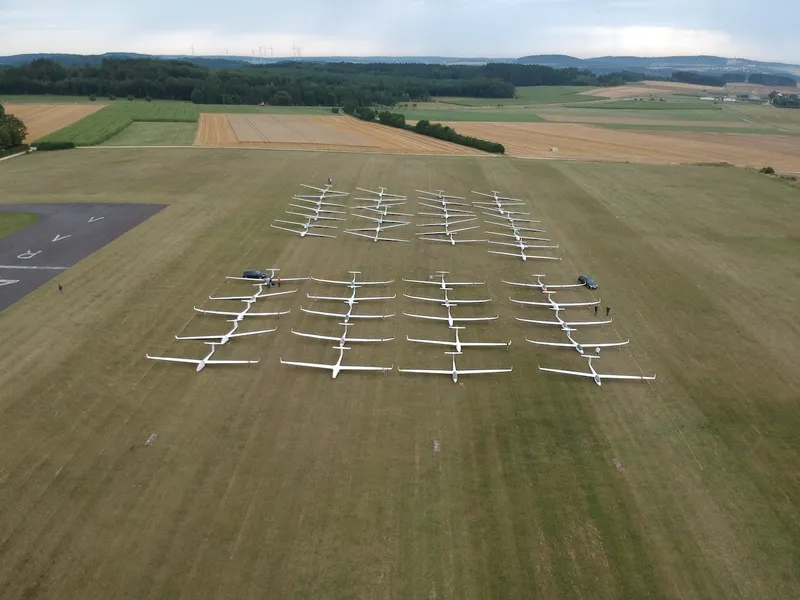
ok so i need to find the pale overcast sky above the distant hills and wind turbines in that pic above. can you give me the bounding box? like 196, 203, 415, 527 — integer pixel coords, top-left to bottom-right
0, 0, 800, 63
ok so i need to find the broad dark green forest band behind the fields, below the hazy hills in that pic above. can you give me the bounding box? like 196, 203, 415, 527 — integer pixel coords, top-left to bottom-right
0, 58, 642, 106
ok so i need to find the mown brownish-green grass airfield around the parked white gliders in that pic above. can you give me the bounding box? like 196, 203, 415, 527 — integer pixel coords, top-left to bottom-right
0, 149, 800, 599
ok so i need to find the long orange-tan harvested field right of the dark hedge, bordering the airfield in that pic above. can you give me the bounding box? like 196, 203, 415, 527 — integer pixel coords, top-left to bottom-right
438, 123, 800, 171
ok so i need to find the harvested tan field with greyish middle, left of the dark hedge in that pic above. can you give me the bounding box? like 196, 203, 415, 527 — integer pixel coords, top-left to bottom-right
194, 114, 482, 154
